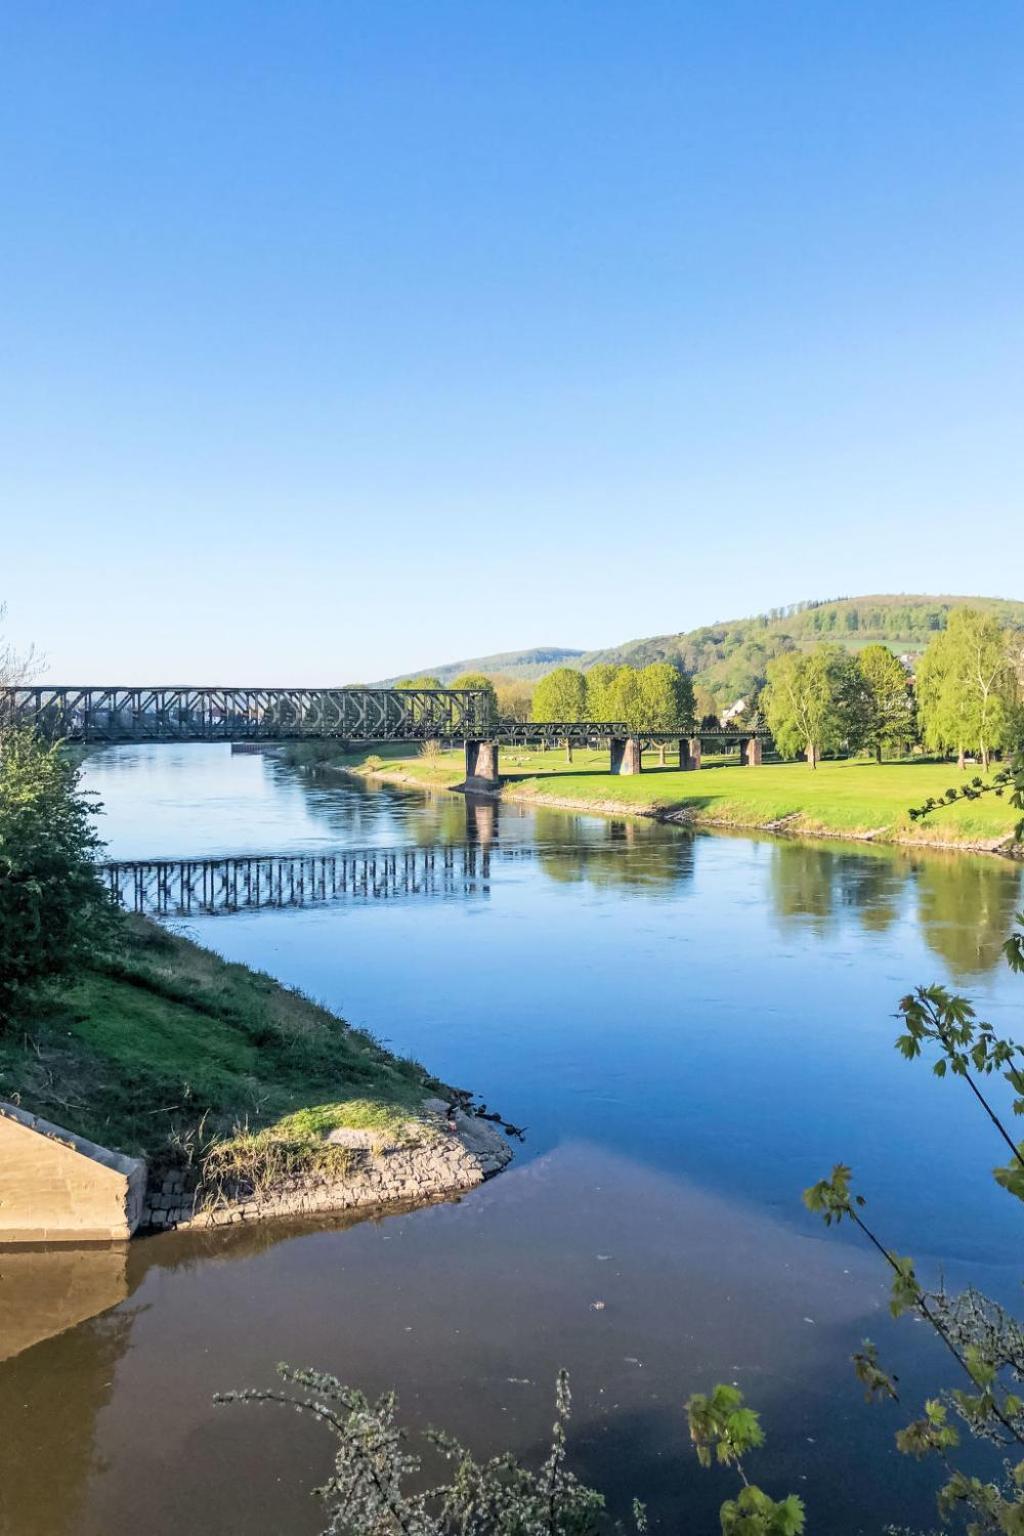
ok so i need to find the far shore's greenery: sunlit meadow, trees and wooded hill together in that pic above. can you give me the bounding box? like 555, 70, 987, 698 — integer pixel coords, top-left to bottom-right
320, 598, 1024, 852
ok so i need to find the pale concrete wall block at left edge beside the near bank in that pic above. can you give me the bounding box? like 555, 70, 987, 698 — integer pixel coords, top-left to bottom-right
0, 1100, 146, 1244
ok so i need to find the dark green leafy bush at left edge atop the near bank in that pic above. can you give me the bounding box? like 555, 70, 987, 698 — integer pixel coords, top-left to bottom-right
0, 730, 115, 1028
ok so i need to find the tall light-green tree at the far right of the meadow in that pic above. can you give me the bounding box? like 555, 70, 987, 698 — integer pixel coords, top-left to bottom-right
917, 608, 1016, 770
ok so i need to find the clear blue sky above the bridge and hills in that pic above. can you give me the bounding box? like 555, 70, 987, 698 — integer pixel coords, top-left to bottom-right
0, 0, 1024, 682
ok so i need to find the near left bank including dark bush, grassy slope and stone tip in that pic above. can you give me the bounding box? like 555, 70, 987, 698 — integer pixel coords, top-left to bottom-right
0, 737, 511, 1227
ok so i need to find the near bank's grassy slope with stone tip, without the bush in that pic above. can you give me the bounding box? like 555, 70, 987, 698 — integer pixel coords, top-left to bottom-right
0, 919, 511, 1227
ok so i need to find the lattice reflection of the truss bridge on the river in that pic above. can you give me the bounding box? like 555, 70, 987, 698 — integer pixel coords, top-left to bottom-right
100, 843, 533, 917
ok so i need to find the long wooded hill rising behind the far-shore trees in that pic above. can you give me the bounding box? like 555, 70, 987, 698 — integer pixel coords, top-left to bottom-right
396, 593, 1024, 705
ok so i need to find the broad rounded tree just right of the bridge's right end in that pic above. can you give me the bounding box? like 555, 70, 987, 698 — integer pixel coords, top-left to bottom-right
761, 645, 870, 768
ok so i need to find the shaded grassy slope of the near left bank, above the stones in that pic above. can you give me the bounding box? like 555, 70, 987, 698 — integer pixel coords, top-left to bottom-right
0, 919, 448, 1174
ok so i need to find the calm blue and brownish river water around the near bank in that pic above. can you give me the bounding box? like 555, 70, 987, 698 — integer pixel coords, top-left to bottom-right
0, 746, 1021, 1536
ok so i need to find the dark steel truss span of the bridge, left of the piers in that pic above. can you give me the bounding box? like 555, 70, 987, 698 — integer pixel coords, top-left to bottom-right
0, 687, 496, 742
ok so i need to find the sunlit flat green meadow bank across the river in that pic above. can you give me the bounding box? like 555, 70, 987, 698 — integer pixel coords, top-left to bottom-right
282, 746, 1019, 854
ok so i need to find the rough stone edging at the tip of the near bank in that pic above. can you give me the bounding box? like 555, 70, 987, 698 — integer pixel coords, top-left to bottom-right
140, 1098, 513, 1232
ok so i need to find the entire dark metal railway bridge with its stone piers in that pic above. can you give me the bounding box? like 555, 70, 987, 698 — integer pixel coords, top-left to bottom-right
0, 685, 771, 790
